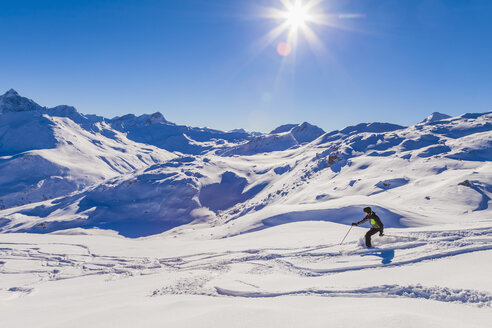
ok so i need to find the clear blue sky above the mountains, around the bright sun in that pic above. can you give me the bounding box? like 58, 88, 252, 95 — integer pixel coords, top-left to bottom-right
0, 0, 492, 131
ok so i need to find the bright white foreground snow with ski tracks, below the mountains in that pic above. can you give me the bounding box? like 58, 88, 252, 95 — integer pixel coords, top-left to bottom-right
0, 222, 492, 327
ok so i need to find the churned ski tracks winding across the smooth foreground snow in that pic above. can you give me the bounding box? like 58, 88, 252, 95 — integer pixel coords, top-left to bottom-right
0, 228, 492, 306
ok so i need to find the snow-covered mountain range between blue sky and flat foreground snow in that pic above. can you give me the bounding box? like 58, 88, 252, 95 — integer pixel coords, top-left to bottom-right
0, 90, 492, 237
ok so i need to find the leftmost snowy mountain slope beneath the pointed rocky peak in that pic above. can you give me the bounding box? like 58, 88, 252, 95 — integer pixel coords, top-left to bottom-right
0, 90, 176, 208
